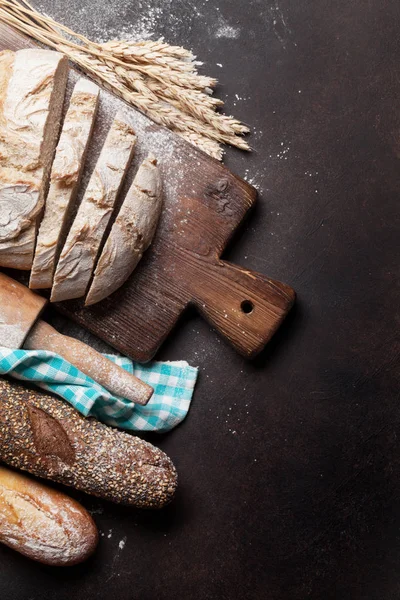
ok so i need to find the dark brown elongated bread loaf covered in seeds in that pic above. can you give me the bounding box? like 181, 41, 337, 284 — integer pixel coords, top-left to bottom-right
0, 379, 177, 508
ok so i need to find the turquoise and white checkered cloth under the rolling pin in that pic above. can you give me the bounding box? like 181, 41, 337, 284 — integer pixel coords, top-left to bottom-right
0, 346, 198, 431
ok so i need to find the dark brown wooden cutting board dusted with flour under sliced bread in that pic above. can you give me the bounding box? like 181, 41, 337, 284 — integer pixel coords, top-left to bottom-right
0, 24, 295, 362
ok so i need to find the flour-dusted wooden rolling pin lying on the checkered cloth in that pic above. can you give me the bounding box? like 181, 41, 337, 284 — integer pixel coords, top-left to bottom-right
0, 273, 154, 405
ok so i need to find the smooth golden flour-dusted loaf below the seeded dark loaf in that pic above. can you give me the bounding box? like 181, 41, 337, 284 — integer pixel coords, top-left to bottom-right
0, 467, 98, 566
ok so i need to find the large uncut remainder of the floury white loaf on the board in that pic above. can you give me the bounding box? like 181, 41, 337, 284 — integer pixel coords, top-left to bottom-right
0, 49, 68, 269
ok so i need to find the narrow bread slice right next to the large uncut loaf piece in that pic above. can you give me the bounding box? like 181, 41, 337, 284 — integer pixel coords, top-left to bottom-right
29, 78, 100, 289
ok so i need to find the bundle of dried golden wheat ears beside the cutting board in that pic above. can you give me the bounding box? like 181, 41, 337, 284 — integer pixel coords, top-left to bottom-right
0, 0, 250, 160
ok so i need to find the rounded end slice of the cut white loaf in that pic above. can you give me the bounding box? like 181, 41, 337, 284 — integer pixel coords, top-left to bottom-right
85, 155, 162, 306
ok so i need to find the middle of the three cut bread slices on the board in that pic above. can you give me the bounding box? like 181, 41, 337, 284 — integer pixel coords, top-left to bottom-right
51, 112, 136, 302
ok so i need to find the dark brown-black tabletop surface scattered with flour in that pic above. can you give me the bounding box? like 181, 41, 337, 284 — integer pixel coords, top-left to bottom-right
0, 0, 400, 600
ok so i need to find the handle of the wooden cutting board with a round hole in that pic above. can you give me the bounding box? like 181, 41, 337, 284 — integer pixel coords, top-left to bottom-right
189, 260, 295, 358
